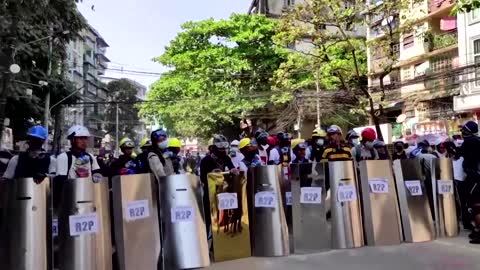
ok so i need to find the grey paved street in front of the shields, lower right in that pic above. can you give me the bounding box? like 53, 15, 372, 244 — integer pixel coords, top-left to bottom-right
209, 237, 480, 270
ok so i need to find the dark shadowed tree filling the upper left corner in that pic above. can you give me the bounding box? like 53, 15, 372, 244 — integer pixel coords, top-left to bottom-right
0, 0, 85, 140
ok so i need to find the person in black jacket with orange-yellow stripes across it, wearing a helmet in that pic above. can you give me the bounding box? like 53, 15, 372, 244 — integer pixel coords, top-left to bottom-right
322, 125, 352, 161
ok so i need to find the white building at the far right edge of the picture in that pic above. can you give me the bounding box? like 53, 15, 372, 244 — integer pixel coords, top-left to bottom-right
453, 9, 480, 118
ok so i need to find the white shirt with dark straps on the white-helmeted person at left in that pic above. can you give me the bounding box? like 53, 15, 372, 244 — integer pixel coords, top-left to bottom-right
57, 153, 100, 179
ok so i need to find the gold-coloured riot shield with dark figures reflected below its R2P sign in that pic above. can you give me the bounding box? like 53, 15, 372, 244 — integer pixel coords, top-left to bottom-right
208, 172, 251, 262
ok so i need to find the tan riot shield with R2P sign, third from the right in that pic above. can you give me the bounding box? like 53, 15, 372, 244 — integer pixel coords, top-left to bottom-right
359, 160, 403, 246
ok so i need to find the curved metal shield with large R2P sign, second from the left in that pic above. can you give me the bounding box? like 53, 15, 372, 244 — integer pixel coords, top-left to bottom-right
58, 178, 112, 270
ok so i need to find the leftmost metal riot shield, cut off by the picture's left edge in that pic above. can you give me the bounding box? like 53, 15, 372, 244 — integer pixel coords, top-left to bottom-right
0, 178, 52, 270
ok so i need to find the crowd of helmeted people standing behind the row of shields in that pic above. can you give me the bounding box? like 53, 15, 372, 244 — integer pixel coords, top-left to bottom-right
0, 121, 480, 247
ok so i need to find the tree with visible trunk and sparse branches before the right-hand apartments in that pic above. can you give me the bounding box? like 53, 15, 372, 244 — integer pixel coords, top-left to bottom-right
276, 0, 410, 138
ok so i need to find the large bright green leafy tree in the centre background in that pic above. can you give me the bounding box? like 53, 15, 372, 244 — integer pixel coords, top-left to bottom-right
141, 14, 286, 137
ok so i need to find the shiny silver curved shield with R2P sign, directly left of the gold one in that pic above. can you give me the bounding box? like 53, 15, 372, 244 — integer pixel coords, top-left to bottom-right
160, 174, 210, 269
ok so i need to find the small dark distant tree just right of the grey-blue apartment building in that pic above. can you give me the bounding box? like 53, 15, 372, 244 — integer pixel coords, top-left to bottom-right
105, 79, 140, 139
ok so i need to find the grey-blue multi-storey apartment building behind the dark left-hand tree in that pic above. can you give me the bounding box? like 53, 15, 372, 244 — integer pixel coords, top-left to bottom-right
65, 22, 110, 151
